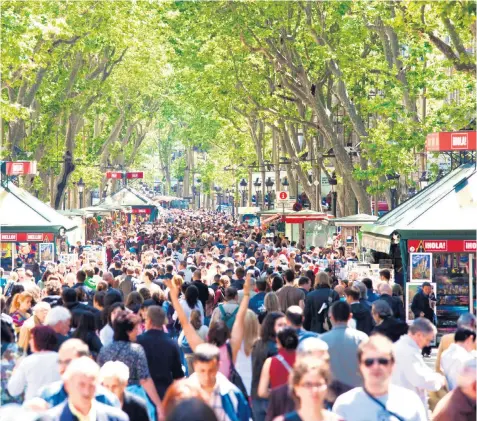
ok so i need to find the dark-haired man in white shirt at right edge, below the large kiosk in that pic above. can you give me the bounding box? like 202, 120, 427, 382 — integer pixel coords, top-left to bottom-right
441, 329, 476, 390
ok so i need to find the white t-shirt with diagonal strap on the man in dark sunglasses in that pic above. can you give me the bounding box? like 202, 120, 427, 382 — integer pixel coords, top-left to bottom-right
333, 385, 427, 421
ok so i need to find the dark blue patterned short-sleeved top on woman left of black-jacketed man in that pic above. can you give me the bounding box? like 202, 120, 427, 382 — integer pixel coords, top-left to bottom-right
97, 341, 151, 385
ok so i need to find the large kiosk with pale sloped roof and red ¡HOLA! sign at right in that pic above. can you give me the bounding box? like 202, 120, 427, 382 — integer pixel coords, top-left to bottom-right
362, 163, 477, 335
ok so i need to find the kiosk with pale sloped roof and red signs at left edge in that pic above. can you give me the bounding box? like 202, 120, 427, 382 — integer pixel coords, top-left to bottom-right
0, 182, 77, 271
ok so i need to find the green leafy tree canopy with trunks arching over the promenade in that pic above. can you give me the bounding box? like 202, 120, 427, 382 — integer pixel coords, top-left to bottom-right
1, 1, 476, 215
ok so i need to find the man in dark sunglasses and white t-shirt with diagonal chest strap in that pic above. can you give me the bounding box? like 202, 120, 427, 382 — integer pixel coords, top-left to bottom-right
333, 334, 427, 421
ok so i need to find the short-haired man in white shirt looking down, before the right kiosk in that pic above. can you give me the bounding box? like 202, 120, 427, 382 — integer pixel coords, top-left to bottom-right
391, 317, 445, 410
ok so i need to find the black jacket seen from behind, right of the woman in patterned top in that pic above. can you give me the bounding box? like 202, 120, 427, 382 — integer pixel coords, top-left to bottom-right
137, 329, 184, 399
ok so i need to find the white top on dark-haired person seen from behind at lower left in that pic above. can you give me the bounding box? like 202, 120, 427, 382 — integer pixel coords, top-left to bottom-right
8, 351, 61, 401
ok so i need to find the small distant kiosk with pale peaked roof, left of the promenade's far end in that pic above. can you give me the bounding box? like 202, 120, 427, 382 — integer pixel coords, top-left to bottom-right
98, 185, 158, 222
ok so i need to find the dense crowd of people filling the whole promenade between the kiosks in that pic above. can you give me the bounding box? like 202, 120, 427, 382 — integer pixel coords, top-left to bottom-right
0, 210, 476, 421
